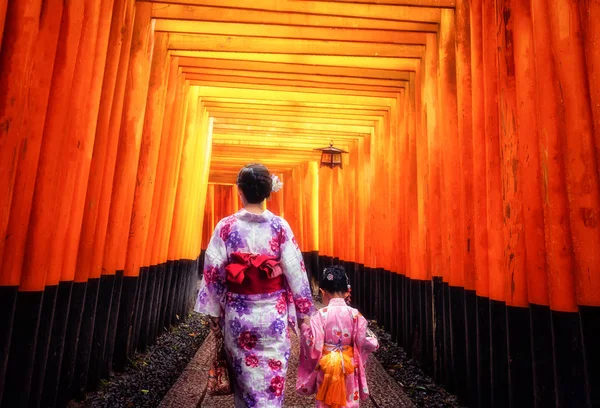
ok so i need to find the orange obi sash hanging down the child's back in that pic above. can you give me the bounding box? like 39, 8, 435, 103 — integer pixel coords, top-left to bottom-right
317, 344, 354, 408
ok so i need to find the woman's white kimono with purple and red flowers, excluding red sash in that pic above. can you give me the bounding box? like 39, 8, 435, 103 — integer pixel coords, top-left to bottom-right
195, 210, 314, 408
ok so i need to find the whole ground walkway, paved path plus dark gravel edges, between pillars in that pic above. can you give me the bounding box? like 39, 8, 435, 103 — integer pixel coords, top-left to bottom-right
69, 302, 461, 408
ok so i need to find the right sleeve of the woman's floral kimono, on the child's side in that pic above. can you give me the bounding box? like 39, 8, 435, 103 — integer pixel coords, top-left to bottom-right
280, 220, 315, 320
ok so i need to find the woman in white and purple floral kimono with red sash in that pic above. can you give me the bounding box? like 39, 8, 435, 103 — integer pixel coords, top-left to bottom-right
195, 164, 314, 408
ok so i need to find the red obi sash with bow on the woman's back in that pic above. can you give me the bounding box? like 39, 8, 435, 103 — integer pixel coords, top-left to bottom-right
225, 252, 285, 295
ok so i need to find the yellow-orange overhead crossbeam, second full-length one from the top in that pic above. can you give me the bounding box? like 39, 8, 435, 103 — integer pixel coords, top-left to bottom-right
154, 18, 437, 45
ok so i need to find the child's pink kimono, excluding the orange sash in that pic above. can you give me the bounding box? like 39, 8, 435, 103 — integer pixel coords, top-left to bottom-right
296, 298, 379, 408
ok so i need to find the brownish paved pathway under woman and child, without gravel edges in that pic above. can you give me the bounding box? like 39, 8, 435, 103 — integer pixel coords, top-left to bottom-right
159, 314, 414, 408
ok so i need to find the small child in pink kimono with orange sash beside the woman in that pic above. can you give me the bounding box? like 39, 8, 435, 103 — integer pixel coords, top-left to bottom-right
296, 266, 379, 408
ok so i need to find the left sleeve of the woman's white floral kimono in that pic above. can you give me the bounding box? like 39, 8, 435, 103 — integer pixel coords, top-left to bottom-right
194, 225, 227, 317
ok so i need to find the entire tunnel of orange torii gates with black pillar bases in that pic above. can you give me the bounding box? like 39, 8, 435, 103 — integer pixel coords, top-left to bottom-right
0, 0, 600, 408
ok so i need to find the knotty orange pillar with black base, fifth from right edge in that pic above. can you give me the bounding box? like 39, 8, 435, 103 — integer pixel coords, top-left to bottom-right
491, 0, 532, 406
